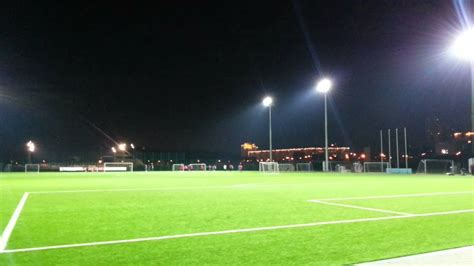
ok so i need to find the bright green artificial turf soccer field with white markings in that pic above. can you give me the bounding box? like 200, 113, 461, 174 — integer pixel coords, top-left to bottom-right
0, 172, 474, 265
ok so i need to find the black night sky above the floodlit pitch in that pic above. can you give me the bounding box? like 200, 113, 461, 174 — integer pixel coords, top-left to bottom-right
0, 0, 470, 158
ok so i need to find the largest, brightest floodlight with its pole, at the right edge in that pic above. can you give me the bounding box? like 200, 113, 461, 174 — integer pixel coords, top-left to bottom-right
450, 26, 474, 156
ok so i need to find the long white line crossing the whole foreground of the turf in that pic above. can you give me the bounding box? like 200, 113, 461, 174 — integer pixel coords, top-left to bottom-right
0, 209, 474, 254
